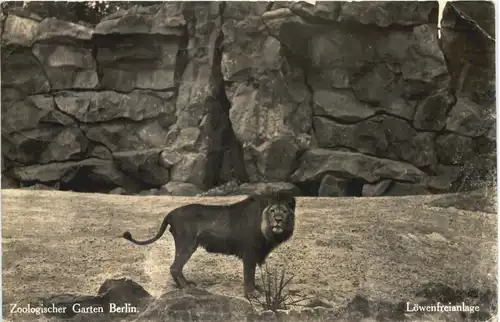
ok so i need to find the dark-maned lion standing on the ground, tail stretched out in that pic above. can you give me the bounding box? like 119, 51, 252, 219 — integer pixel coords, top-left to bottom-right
123, 193, 296, 298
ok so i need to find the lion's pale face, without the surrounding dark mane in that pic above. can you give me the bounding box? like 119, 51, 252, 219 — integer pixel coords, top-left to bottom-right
261, 203, 295, 239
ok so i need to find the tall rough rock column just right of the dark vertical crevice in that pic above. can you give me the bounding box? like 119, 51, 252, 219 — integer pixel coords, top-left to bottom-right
221, 2, 312, 182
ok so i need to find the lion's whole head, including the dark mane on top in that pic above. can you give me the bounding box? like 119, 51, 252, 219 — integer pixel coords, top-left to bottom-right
260, 197, 295, 241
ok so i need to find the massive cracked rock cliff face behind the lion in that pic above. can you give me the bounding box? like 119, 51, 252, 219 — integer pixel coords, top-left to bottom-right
2, 2, 496, 196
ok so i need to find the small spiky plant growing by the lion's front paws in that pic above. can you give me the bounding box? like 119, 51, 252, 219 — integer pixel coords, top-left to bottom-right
248, 265, 308, 312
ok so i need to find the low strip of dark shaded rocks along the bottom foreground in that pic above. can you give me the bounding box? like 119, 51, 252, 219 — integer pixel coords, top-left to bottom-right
26, 278, 496, 322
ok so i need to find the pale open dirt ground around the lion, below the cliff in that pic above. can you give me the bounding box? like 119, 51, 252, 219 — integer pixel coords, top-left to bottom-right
2, 190, 497, 320
